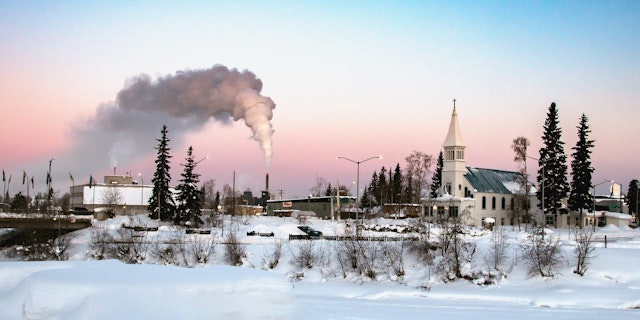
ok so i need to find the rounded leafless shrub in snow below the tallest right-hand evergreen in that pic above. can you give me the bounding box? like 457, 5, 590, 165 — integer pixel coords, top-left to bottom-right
522, 233, 563, 277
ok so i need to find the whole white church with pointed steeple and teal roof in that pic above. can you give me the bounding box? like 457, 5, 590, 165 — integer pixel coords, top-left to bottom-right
424, 100, 543, 226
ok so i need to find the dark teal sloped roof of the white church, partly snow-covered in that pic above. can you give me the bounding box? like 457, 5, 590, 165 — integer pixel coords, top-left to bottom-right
465, 167, 520, 194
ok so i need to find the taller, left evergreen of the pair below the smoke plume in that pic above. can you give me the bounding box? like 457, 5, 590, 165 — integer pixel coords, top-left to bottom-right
147, 125, 176, 221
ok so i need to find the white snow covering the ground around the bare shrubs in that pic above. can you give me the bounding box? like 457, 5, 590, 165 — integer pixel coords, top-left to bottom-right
0, 217, 640, 319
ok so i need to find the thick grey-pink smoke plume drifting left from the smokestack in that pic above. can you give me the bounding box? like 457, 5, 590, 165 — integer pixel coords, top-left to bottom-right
69, 65, 275, 174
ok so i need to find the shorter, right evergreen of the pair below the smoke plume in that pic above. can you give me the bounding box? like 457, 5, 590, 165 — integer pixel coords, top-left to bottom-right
174, 146, 204, 227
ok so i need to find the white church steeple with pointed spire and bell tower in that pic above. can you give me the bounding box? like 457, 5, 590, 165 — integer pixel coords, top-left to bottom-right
442, 99, 467, 197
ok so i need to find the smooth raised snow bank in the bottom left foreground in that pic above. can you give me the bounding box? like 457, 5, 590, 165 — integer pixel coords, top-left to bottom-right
0, 261, 292, 319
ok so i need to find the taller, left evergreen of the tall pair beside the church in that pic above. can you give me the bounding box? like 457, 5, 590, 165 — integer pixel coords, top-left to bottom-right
537, 102, 569, 223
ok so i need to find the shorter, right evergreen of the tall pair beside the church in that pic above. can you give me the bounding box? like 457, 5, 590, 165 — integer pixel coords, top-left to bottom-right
569, 114, 594, 227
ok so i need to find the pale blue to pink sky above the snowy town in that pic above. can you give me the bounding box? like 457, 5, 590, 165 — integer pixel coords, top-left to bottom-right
0, 1, 640, 197
